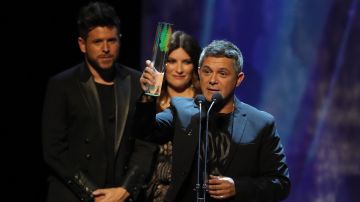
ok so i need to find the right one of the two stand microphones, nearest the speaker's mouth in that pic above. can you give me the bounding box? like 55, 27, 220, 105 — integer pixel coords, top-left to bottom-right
203, 93, 223, 199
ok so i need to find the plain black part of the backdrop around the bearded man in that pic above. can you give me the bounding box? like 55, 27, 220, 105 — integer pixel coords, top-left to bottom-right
1, 0, 141, 201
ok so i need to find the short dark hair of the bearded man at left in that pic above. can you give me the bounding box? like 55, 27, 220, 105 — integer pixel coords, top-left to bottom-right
77, 2, 120, 39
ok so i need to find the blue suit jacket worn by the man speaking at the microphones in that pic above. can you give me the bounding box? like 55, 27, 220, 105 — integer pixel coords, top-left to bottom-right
137, 97, 290, 201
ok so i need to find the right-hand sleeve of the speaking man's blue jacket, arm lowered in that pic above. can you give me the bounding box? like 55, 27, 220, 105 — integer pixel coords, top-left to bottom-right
234, 121, 290, 202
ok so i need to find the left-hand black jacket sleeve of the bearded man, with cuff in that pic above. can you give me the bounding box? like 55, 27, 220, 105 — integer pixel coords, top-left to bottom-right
42, 79, 96, 201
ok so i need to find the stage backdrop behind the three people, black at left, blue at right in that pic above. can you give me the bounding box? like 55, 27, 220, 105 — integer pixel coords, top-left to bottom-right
1, 0, 360, 202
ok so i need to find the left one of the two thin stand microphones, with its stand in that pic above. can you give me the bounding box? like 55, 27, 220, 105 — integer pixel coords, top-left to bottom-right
195, 95, 206, 202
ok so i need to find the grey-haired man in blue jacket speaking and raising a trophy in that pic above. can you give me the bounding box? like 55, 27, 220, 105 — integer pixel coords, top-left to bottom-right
136, 40, 290, 202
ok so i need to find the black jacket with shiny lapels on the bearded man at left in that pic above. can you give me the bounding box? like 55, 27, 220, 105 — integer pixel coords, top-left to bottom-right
42, 63, 155, 202
